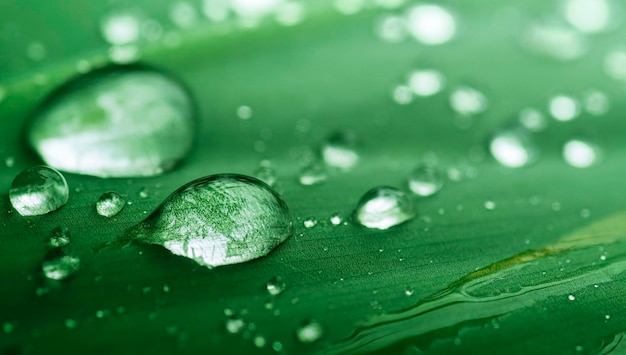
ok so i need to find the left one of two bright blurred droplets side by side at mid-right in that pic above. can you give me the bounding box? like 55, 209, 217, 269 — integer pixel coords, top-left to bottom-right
489, 129, 539, 168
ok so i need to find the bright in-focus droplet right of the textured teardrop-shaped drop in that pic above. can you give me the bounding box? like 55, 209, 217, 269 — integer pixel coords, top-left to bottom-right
354, 186, 415, 230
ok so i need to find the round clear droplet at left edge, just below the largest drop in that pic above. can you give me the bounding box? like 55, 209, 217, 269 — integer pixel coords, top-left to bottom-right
9, 166, 69, 216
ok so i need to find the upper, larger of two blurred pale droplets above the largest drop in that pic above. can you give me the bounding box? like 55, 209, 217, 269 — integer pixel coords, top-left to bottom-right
100, 11, 140, 45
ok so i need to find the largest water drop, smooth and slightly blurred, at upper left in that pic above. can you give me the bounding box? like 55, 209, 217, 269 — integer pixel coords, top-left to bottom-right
28, 67, 194, 177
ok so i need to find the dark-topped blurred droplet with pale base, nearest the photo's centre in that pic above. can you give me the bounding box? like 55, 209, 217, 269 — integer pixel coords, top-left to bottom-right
321, 130, 359, 170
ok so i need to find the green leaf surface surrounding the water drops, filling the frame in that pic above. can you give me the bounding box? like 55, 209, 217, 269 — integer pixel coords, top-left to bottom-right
0, 0, 626, 354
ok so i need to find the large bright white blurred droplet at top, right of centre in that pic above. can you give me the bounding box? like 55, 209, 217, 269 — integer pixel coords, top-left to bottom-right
407, 4, 456, 45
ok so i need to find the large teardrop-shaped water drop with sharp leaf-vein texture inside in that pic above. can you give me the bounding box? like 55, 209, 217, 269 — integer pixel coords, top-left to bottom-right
126, 174, 293, 267
